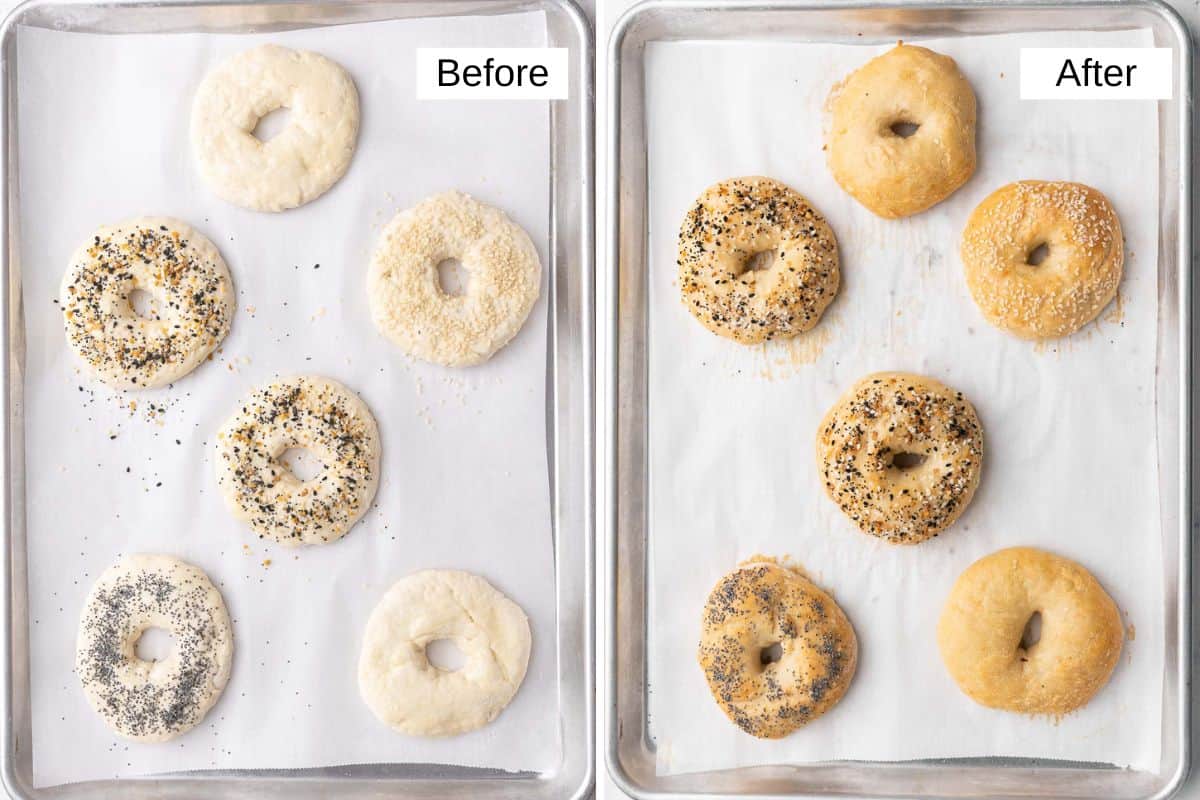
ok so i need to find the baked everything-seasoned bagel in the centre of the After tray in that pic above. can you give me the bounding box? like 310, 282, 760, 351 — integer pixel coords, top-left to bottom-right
817, 372, 983, 545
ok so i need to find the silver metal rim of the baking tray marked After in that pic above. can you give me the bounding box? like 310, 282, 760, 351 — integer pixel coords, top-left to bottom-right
599, 0, 1200, 800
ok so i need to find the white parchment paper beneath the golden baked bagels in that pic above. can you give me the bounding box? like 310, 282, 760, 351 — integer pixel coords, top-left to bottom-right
646, 30, 1165, 774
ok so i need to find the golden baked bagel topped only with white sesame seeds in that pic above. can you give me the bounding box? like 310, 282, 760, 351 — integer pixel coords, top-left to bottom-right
960, 181, 1124, 339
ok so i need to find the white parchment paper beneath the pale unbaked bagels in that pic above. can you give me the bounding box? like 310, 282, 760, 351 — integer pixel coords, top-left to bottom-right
18, 12, 559, 786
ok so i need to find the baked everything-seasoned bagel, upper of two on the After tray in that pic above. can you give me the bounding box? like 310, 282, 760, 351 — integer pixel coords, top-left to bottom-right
679, 178, 841, 344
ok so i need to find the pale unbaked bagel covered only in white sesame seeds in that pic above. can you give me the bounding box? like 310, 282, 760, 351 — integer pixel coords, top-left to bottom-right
367, 192, 541, 367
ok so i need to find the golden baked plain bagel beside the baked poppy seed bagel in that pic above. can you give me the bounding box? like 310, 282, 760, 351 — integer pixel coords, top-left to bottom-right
937, 547, 1124, 715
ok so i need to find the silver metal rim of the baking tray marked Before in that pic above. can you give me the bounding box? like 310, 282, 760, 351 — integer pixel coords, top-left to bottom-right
0, 0, 595, 800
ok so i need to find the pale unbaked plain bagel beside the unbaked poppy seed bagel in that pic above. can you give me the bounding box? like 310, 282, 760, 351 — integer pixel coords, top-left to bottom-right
359, 570, 532, 736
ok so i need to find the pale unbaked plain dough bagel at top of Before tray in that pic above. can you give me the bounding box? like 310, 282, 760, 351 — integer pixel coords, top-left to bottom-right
192, 44, 359, 211
